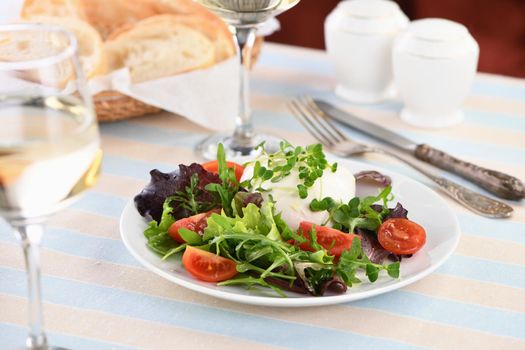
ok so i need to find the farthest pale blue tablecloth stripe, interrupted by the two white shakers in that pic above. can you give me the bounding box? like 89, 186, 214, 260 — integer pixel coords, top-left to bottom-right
258, 50, 525, 101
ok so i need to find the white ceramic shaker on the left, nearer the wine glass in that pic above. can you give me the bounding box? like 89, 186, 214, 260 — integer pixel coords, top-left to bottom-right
325, 0, 408, 103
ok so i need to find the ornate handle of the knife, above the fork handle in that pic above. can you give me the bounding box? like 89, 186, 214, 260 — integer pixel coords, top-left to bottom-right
415, 144, 525, 200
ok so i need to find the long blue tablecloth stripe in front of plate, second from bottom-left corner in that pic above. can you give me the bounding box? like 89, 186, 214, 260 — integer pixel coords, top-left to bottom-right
0, 268, 415, 350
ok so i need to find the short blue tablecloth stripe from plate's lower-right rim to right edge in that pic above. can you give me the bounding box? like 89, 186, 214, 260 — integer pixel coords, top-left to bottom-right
437, 255, 525, 288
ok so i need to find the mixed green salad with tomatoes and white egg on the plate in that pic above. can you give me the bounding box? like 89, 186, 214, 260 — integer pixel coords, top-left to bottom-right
135, 141, 426, 296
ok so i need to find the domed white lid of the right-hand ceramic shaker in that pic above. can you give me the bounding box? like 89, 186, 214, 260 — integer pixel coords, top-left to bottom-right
394, 18, 479, 58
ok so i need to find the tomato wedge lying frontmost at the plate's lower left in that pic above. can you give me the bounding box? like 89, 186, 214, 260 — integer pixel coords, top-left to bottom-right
182, 246, 237, 282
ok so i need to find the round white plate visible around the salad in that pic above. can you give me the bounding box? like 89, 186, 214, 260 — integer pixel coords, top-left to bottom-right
120, 160, 460, 307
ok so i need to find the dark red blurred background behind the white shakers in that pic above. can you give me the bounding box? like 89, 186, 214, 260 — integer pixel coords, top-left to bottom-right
268, 0, 525, 78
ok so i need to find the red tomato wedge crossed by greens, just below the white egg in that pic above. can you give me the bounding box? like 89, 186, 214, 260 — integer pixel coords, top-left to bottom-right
297, 221, 361, 259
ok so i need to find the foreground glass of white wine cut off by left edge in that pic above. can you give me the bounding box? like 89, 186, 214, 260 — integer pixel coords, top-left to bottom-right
0, 24, 102, 350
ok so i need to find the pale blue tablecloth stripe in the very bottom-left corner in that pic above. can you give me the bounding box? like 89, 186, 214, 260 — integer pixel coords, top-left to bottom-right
0, 320, 134, 350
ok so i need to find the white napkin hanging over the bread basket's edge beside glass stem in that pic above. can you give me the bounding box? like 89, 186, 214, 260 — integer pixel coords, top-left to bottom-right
89, 58, 239, 131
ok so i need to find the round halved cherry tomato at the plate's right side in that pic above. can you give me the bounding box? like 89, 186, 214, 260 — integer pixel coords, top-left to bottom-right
377, 218, 427, 255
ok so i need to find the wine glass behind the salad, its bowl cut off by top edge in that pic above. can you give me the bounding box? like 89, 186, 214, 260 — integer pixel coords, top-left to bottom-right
195, 0, 299, 159
